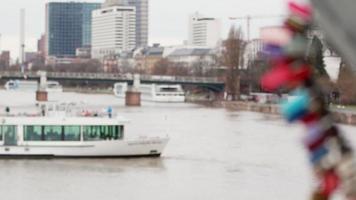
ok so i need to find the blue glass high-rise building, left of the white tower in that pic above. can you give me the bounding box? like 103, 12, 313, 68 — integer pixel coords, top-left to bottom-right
46, 2, 101, 57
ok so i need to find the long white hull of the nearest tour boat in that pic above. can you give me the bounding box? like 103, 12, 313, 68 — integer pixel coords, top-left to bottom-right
0, 138, 168, 158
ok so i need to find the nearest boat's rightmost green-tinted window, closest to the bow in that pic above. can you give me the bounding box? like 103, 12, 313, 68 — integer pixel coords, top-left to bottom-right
83, 126, 123, 141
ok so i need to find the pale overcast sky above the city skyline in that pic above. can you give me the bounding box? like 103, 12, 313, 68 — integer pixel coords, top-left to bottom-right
0, 0, 286, 58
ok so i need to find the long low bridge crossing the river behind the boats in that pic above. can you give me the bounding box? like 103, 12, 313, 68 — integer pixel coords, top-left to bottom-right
0, 71, 225, 92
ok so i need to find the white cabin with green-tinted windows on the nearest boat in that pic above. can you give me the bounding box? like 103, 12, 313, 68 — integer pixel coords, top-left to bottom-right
0, 117, 124, 146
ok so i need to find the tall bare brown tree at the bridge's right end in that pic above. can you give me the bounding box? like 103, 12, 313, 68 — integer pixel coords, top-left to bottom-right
222, 26, 246, 101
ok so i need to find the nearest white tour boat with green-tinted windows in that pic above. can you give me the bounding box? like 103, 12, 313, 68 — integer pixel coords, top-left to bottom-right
0, 103, 168, 158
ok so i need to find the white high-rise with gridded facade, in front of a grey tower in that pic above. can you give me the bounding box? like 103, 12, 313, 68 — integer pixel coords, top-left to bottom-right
92, 6, 136, 60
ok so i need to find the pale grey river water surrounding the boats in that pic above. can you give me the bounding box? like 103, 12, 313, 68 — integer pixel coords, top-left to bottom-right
0, 91, 356, 200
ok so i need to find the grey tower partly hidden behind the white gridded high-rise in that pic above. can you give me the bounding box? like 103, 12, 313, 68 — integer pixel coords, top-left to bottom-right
103, 0, 149, 47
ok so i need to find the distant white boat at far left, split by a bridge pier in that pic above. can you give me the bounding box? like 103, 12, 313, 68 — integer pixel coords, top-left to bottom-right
4, 80, 63, 92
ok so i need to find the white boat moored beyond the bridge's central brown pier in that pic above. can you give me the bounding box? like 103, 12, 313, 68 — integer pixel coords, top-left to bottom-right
114, 83, 185, 103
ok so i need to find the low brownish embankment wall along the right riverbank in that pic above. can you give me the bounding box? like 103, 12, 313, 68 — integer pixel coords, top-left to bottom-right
211, 101, 356, 126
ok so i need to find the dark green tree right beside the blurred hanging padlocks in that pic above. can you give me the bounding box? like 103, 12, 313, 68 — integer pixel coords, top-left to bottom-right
307, 36, 329, 77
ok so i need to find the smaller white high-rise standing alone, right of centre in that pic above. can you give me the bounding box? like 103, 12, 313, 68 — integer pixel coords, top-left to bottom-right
188, 13, 221, 47
